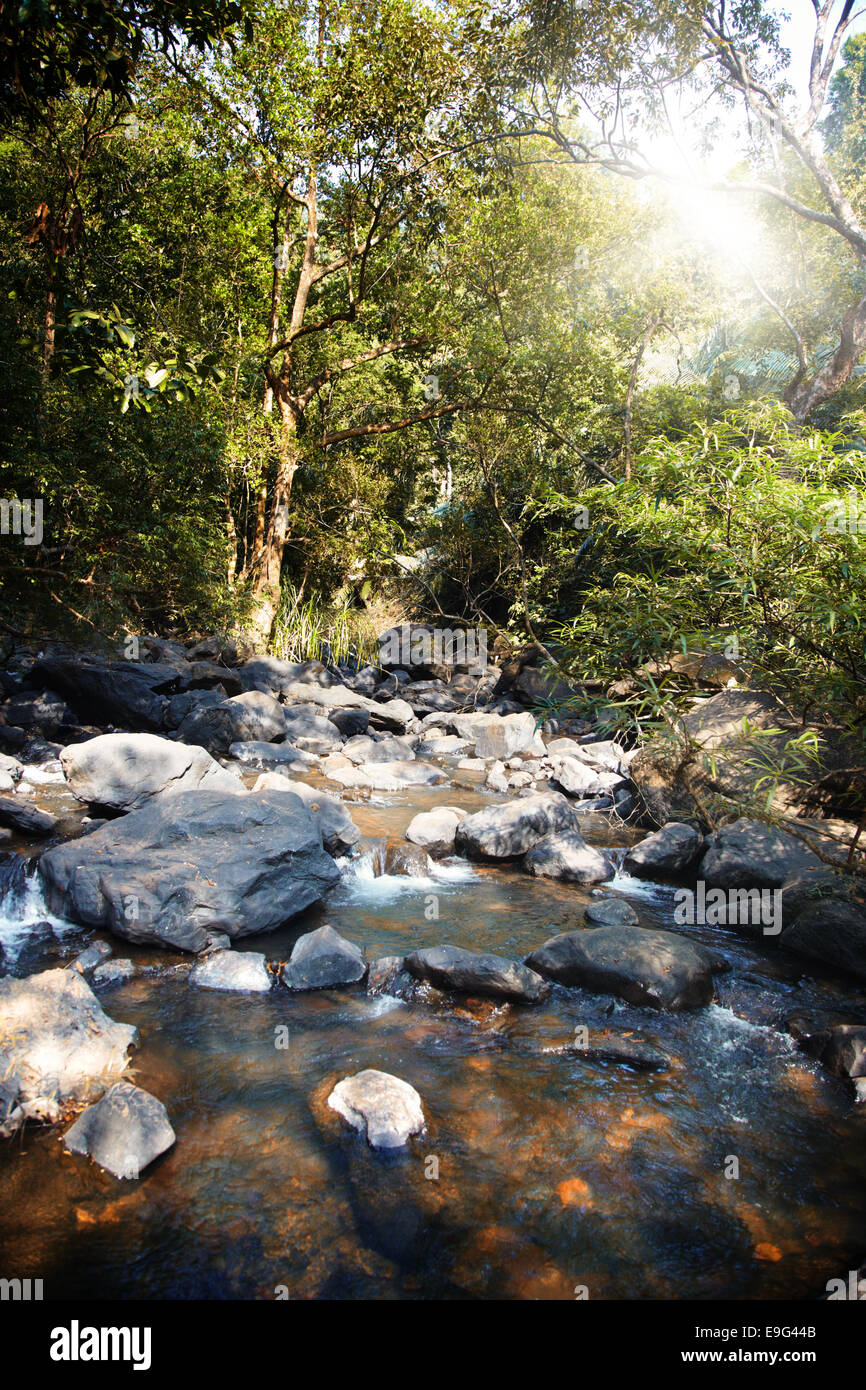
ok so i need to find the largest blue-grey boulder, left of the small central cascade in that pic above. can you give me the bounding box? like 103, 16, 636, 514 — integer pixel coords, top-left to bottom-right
40, 791, 339, 952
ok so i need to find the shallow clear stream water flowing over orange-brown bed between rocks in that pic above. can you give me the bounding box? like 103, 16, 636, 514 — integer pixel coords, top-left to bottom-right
0, 785, 866, 1300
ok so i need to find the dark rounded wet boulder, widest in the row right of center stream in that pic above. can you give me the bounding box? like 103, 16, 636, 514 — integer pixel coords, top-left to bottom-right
527, 927, 713, 1011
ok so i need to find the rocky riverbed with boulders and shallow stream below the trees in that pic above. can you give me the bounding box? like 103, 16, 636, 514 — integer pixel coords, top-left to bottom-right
0, 639, 866, 1298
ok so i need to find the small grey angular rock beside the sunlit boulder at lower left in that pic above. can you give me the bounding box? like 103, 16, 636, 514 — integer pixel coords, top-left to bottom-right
64, 1081, 177, 1179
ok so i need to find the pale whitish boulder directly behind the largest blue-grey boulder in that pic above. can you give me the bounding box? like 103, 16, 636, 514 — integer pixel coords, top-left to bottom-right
60, 734, 243, 810
